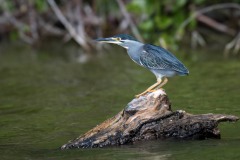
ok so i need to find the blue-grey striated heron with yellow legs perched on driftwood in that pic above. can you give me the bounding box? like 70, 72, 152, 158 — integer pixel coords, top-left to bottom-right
96, 34, 189, 97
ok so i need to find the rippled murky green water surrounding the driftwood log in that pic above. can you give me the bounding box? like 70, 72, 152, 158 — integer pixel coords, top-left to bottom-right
0, 43, 240, 160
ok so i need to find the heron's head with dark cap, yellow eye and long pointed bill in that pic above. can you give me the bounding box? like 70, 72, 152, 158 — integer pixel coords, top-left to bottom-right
96, 34, 140, 49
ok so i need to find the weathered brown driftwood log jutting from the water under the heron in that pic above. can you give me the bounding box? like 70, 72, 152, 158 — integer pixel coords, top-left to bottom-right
61, 90, 239, 149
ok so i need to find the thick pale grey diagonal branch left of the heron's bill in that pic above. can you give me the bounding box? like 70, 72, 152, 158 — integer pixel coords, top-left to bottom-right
48, 0, 90, 51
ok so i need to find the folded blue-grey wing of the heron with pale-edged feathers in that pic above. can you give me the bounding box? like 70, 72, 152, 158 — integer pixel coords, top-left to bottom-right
139, 44, 188, 74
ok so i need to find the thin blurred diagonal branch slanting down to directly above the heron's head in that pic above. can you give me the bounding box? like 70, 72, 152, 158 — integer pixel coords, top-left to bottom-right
117, 0, 143, 42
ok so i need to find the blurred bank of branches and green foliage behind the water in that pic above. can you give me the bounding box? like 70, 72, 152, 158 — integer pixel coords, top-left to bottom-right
0, 0, 240, 54
